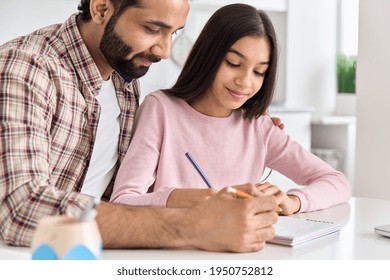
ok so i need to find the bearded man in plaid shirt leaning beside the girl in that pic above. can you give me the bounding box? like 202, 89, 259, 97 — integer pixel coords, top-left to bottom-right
0, 0, 277, 252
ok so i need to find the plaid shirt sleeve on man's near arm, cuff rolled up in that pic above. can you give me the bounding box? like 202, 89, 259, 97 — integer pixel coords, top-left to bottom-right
0, 49, 91, 246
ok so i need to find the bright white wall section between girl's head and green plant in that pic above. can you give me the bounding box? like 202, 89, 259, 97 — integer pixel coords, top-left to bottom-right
286, 0, 337, 115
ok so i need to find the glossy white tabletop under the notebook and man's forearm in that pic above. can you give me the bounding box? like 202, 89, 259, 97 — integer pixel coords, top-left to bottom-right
0, 197, 390, 260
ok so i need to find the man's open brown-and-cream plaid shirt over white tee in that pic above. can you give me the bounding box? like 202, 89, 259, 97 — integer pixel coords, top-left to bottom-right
0, 15, 139, 246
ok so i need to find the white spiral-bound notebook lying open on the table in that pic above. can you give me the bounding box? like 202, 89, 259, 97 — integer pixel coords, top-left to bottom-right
268, 216, 341, 246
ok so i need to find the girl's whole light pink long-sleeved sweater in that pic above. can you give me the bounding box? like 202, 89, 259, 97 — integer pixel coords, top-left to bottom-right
111, 92, 350, 212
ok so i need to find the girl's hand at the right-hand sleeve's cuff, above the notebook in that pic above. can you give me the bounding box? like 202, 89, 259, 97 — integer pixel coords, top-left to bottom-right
256, 182, 301, 216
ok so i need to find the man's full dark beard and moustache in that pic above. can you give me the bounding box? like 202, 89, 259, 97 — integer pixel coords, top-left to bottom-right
99, 15, 161, 82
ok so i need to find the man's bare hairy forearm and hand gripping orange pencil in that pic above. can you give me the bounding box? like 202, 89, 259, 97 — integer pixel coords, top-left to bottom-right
97, 185, 277, 252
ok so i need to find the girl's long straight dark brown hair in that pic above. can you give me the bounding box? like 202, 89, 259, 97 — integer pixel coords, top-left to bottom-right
164, 4, 278, 119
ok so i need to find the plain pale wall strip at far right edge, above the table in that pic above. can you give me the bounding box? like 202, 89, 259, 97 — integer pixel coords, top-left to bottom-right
356, 0, 390, 200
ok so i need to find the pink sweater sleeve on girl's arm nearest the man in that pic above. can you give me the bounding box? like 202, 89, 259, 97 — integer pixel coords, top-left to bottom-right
110, 97, 174, 207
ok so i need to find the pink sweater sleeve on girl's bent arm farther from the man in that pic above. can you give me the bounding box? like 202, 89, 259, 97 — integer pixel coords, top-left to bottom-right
263, 116, 351, 212
